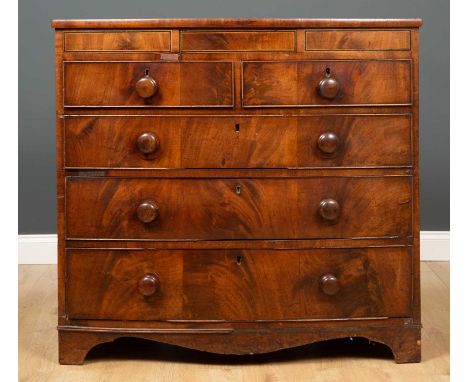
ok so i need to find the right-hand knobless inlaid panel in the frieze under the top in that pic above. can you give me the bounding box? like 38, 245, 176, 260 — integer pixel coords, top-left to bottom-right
306, 29, 411, 50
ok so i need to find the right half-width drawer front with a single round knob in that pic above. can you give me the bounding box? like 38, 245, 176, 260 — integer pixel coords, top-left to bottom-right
242, 60, 412, 107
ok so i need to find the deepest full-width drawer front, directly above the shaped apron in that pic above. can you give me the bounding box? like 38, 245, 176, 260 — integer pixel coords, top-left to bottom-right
66, 247, 411, 321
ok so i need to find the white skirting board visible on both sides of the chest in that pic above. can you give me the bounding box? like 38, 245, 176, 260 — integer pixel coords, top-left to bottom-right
18, 231, 450, 264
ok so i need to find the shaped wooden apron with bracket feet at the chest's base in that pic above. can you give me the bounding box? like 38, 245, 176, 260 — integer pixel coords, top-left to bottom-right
59, 325, 421, 364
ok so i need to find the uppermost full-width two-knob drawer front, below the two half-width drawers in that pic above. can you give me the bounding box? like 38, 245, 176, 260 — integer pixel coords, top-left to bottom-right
65, 115, 411, 168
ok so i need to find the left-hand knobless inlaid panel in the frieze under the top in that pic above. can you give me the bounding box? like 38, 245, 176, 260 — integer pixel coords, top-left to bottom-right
64, 31, 171, 52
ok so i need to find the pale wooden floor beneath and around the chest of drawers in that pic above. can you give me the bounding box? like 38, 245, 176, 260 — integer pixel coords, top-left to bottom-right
19, 262, 450, 382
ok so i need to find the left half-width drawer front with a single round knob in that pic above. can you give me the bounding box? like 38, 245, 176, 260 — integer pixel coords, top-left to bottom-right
64, 62, 233, 107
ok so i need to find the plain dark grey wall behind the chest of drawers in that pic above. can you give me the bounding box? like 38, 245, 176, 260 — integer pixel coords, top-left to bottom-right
19, 0, 449, 234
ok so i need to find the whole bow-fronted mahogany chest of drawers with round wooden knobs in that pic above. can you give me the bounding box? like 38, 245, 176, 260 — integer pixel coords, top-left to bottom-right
52, 19, 421, 364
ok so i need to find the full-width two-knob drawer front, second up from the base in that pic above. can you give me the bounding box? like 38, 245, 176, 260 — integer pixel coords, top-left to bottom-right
66, 176, 412, 240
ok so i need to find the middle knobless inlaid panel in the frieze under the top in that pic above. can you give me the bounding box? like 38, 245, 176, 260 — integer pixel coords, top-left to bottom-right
180, 30, 296, 52
